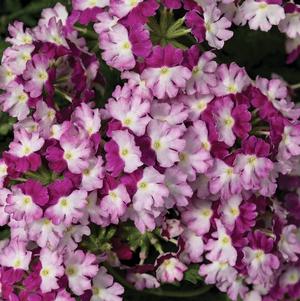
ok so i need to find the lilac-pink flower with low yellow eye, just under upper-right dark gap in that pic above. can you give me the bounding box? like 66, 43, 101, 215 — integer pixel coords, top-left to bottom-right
214, 63, 250, 96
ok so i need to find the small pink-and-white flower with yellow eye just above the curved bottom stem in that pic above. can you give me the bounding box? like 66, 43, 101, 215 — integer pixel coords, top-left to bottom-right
156, 257, 188, 283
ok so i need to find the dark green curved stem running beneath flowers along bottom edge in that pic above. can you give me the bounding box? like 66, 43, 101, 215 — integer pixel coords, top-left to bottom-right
104, 264, 211, 298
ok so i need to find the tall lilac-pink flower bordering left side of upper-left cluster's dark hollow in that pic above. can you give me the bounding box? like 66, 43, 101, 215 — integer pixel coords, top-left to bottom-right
23, 54, 49, 97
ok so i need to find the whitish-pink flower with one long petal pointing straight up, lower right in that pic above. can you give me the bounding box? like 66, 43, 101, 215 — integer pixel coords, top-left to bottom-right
205, 220, 237, 266
